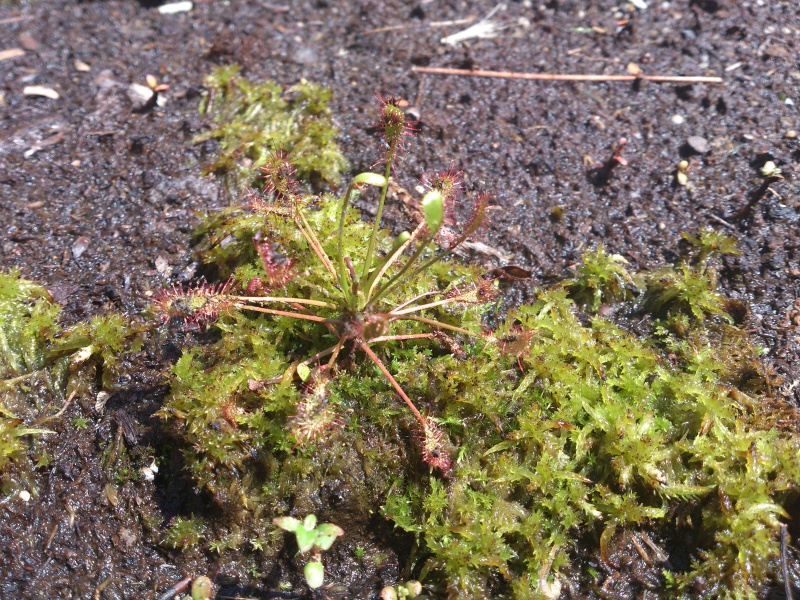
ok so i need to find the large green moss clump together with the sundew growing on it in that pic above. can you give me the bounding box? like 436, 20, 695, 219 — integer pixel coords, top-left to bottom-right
157, 96, 800, 599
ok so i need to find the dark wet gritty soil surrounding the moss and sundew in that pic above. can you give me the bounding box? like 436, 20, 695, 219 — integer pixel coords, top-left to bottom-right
0, 0, 800, 598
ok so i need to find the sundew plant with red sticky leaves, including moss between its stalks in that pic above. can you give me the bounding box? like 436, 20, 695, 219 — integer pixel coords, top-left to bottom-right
155, 98, 494, 471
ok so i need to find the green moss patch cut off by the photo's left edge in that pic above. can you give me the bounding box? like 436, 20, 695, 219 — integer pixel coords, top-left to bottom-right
0, 271, 142, 494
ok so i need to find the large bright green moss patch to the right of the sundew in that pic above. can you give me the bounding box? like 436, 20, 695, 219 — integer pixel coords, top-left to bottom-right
384, 290, 800, 598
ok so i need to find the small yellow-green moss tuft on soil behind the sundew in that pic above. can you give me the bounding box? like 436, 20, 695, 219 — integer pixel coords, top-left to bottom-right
195, 65, 347, 189
